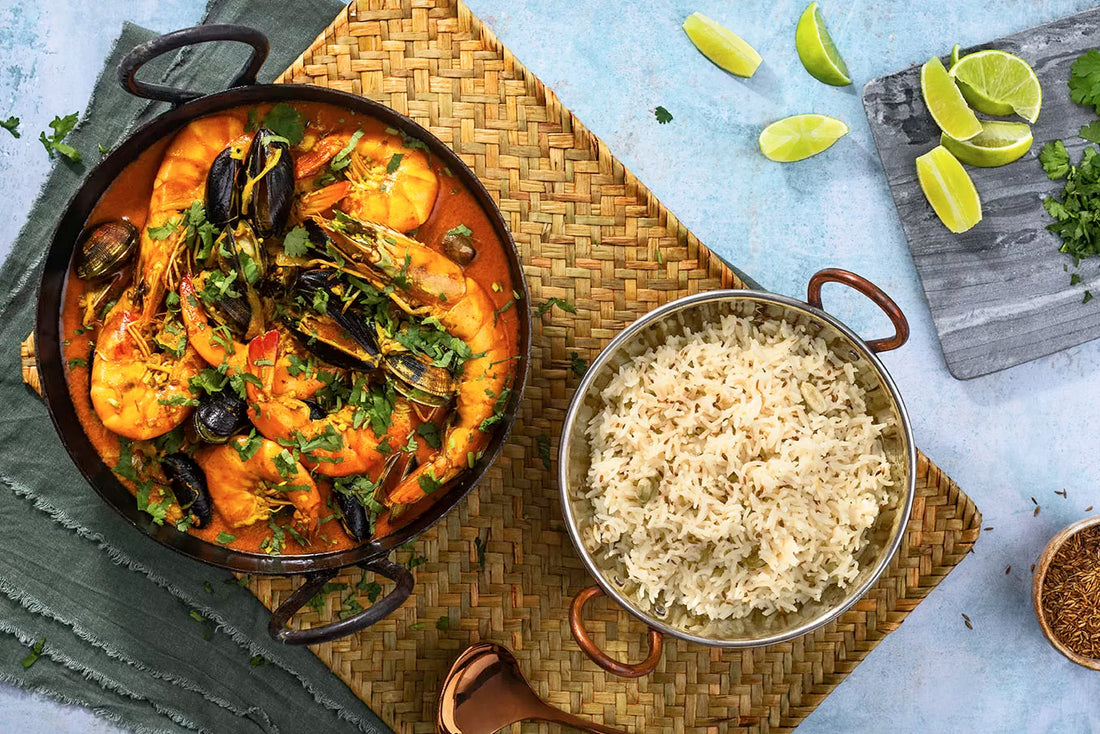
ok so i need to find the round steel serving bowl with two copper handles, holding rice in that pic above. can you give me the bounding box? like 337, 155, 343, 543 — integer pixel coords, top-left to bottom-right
558, 269, 916, 677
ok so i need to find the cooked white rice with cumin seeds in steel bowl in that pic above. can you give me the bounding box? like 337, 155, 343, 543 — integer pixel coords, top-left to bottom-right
582, 315, 893, 620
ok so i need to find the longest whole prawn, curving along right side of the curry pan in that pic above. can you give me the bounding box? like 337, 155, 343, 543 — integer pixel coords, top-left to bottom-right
315, 218, 515, 505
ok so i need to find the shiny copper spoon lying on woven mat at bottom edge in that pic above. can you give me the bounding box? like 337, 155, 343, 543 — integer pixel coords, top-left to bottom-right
436, 643, 628, 734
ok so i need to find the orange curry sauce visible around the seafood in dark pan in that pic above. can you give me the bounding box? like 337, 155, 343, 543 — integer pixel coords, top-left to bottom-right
61, 102, 526, 555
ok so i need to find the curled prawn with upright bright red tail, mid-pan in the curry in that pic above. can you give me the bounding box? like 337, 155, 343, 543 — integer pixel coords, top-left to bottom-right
245, 329, 414, 476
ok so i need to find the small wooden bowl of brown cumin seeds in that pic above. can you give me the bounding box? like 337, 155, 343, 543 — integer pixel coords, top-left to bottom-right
1032, 517, 1100, 670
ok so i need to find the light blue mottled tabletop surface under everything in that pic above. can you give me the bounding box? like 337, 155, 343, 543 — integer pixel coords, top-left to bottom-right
0, 0, 1100, 734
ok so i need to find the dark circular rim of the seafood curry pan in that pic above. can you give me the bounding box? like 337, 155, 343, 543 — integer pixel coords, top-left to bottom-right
34, 63, 531, 574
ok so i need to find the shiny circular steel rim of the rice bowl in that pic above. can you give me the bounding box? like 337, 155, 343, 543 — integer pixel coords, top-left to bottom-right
558, 289, 916, 651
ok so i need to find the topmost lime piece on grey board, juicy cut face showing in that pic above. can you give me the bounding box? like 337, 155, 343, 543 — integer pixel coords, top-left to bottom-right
952, 51, 1043, 122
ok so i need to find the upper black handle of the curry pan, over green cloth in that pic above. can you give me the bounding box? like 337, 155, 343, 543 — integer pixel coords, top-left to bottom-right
119, 24, 270, 107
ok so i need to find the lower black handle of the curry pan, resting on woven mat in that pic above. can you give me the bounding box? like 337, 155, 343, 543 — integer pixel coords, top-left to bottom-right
267, 558, 416, 645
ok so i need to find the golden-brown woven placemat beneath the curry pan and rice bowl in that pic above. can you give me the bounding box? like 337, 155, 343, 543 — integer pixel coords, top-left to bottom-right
240, 0, 981, 732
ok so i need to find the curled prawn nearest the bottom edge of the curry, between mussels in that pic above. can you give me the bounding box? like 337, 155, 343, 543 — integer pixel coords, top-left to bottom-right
195, 436, 321, 534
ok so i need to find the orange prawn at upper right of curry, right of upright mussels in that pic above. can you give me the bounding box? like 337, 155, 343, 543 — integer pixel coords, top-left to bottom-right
295, 133, 439, 232
